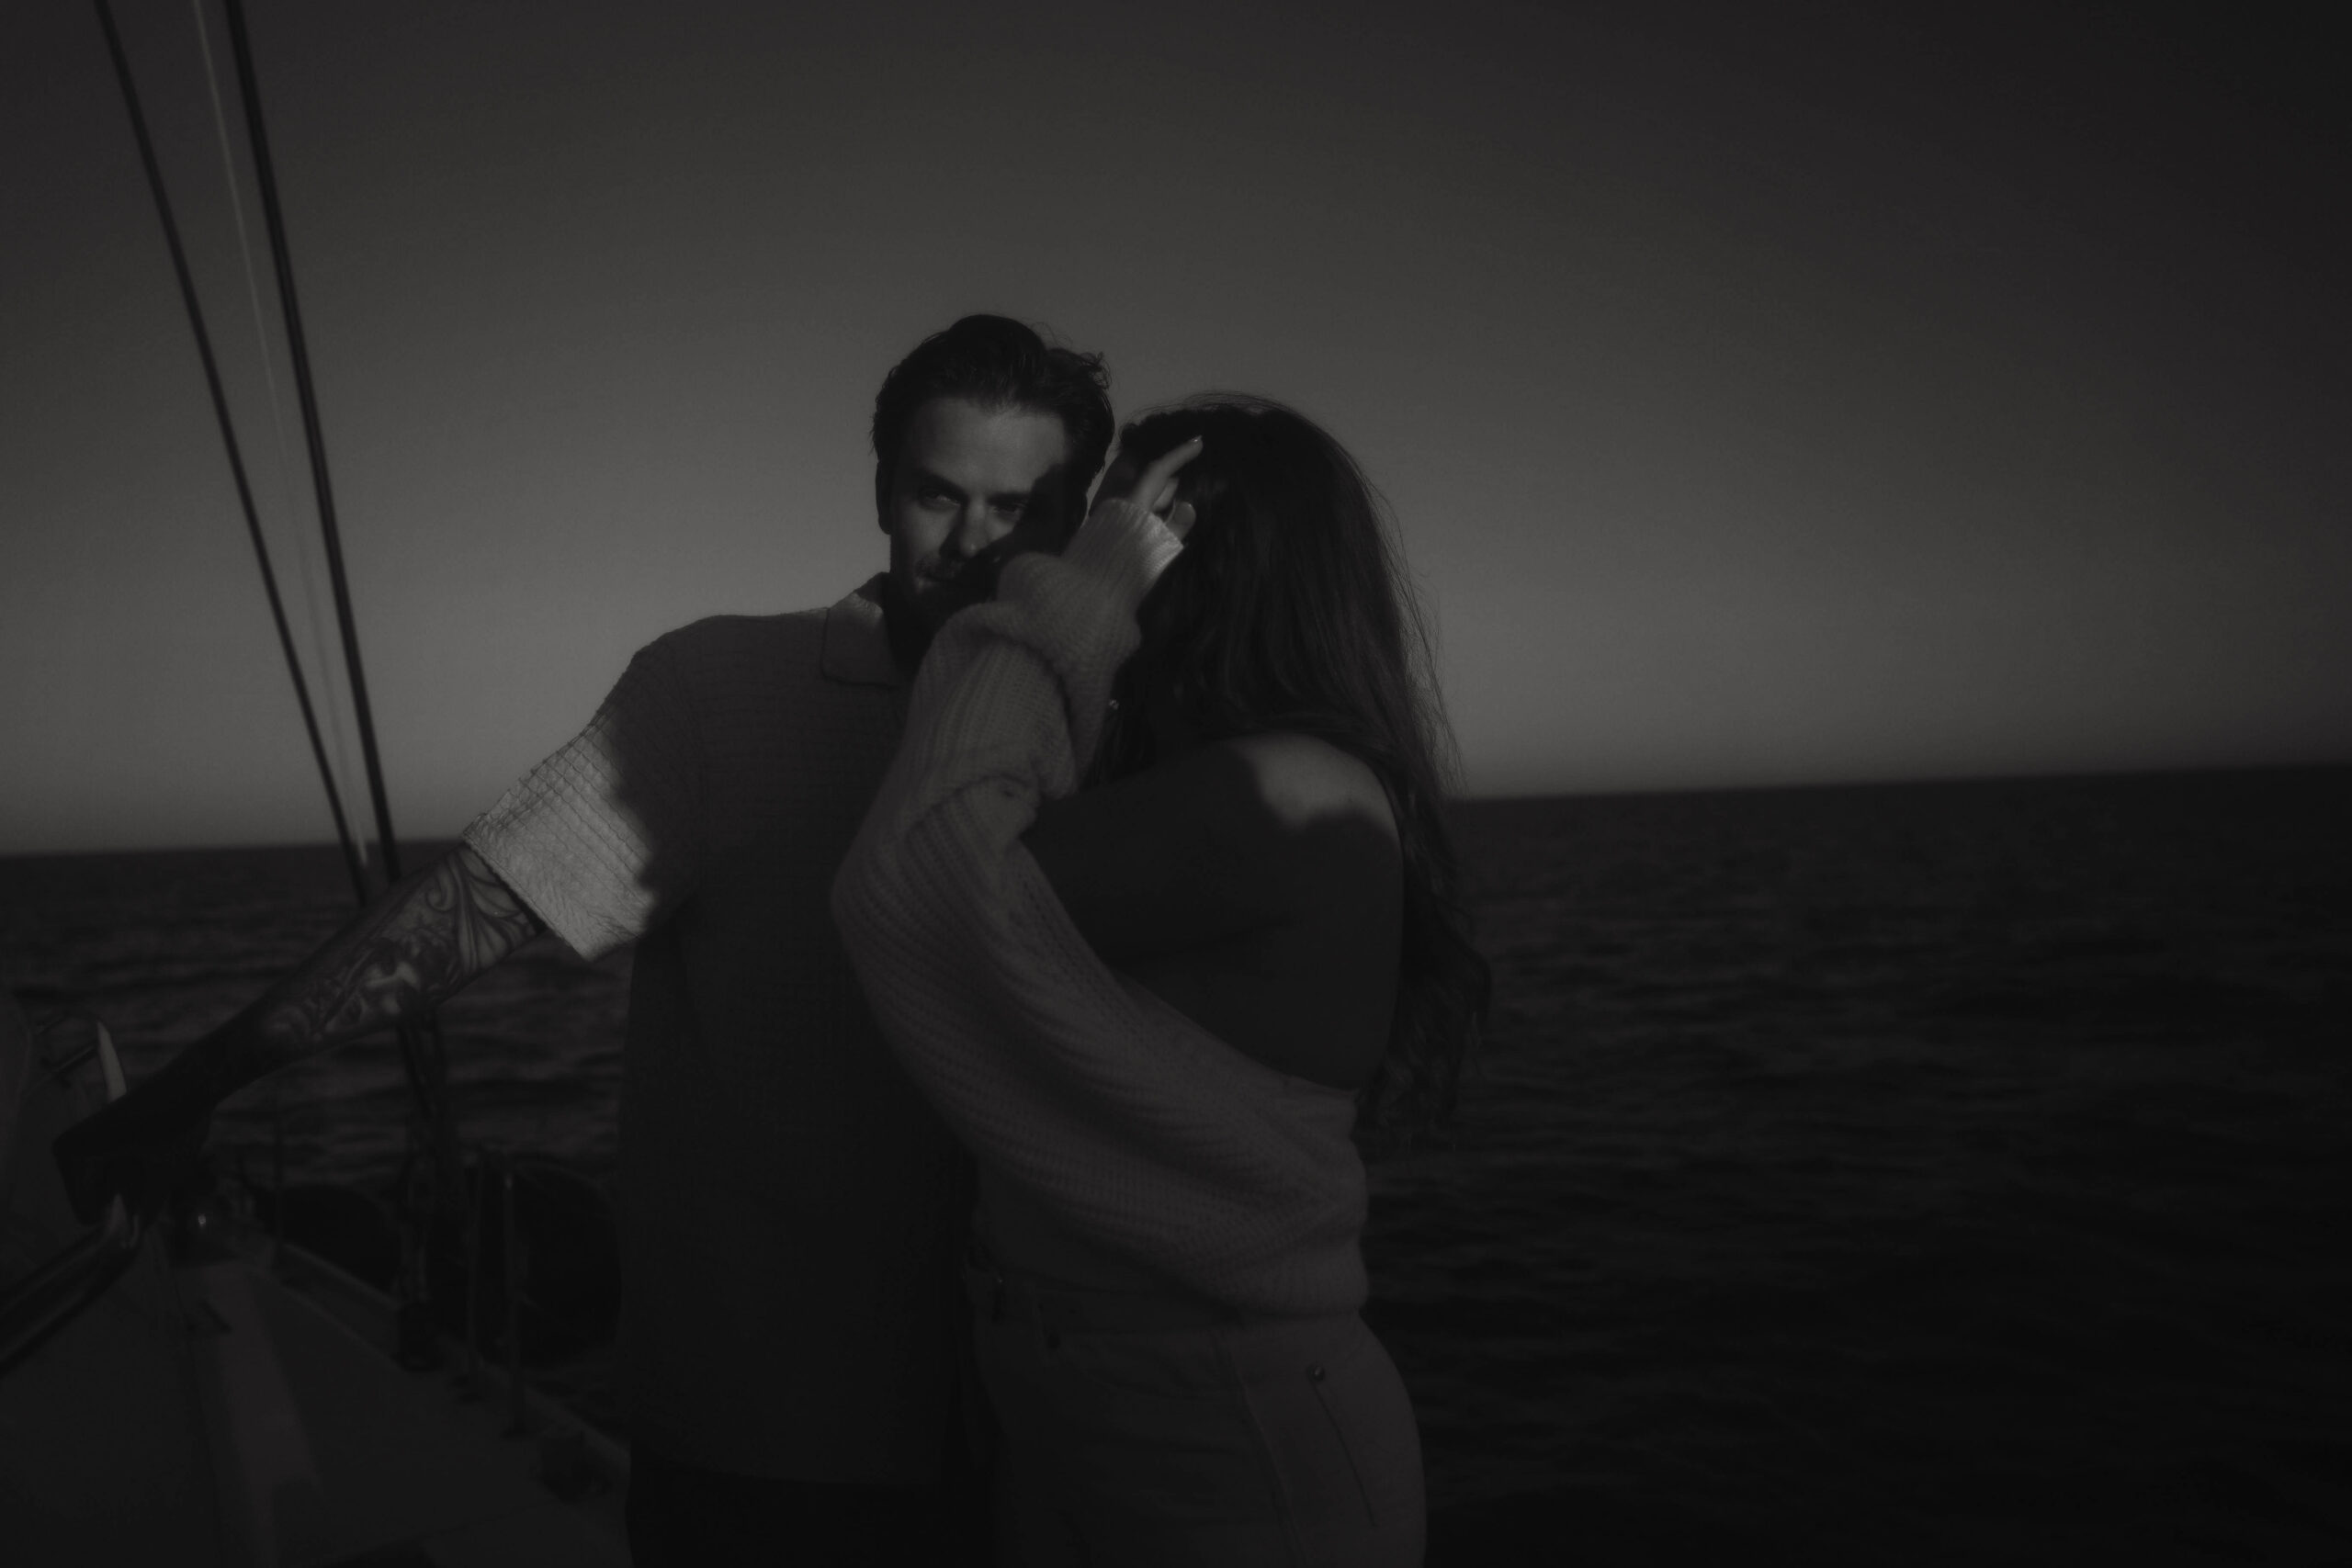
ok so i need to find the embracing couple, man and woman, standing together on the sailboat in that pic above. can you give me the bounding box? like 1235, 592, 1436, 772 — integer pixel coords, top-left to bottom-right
59, 315, 1487, 1568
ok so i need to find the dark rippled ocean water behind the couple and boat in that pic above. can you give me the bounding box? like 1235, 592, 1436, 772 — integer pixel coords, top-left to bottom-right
0, 769, 2352, 1563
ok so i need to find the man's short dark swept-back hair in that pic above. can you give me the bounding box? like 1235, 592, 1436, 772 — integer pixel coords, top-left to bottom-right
875, 315, 1113, 526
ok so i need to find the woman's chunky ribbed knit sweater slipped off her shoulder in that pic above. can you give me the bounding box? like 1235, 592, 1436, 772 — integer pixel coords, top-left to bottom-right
832, 503, 1366, 1316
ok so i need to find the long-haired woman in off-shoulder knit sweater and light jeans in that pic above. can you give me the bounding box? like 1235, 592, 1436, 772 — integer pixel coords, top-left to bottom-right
832, 398, 1487, 1565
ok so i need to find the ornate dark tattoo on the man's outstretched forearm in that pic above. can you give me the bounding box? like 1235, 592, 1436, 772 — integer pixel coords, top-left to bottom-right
254, 849, 546, 1065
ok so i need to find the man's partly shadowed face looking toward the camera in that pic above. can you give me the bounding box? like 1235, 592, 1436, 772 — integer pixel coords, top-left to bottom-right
879, 398, 1077, 632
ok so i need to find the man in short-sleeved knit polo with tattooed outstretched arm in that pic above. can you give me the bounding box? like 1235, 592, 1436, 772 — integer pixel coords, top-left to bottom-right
59, 315, 1113, 1568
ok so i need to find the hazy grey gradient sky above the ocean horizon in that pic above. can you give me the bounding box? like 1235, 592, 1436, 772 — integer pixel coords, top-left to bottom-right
0, 0, 2352, 853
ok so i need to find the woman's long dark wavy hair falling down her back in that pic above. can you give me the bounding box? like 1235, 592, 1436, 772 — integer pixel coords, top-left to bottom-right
1093, 392, 1488, 1155
